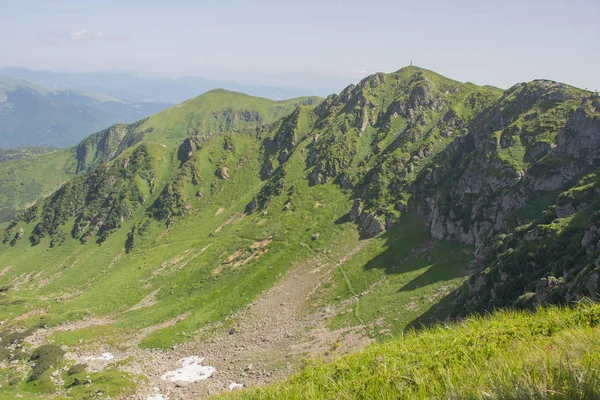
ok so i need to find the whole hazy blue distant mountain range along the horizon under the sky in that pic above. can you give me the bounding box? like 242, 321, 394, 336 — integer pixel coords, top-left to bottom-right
0, 67, 347, 148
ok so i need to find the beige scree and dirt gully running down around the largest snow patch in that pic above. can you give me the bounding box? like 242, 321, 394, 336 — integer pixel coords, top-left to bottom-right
132, 240, 370, 400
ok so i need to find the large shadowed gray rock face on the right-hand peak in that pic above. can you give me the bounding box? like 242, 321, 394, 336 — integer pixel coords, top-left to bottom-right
414, 91, 600, 258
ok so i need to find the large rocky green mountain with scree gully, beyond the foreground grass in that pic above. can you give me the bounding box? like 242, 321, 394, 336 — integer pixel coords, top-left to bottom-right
0, 66, 600, 397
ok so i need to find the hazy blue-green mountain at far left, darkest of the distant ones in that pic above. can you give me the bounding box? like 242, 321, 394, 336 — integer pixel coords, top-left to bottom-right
0, 76, 168, 148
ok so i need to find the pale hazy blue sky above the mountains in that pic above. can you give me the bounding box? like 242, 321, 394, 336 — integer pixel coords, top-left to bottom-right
0, 0, 600, 90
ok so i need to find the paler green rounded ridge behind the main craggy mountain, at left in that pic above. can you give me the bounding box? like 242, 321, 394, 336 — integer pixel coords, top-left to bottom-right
0, 90, 318, 221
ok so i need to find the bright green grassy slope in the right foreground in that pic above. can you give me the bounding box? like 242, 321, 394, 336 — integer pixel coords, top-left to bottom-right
224, 304, 600, 399
